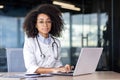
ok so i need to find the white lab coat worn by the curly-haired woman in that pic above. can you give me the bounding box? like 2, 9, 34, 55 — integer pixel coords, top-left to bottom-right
23, 38, 62, 73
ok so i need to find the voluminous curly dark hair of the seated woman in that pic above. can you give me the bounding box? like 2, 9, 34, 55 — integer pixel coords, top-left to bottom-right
23, 4, 64, 38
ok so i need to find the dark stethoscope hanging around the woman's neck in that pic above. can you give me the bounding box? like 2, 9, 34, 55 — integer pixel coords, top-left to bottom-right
36, 36, 58, 60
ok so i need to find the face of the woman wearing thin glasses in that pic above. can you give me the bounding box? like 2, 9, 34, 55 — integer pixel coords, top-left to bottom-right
36, 13, 52, 38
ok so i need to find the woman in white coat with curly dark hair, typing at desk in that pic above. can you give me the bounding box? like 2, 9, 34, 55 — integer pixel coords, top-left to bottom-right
23, 4, 71, 73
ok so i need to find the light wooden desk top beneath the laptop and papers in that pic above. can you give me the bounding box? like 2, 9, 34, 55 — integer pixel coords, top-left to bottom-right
0, 71, 120, 80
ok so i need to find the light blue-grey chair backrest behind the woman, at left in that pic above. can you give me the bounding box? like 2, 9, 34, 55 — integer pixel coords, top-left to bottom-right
6, 48, 26, 72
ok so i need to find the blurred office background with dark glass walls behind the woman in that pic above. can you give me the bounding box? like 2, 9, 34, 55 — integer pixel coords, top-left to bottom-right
0, 0, 120, 72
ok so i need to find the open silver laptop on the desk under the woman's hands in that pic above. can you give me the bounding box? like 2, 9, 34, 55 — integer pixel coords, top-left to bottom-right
53, 48, 103, 76
